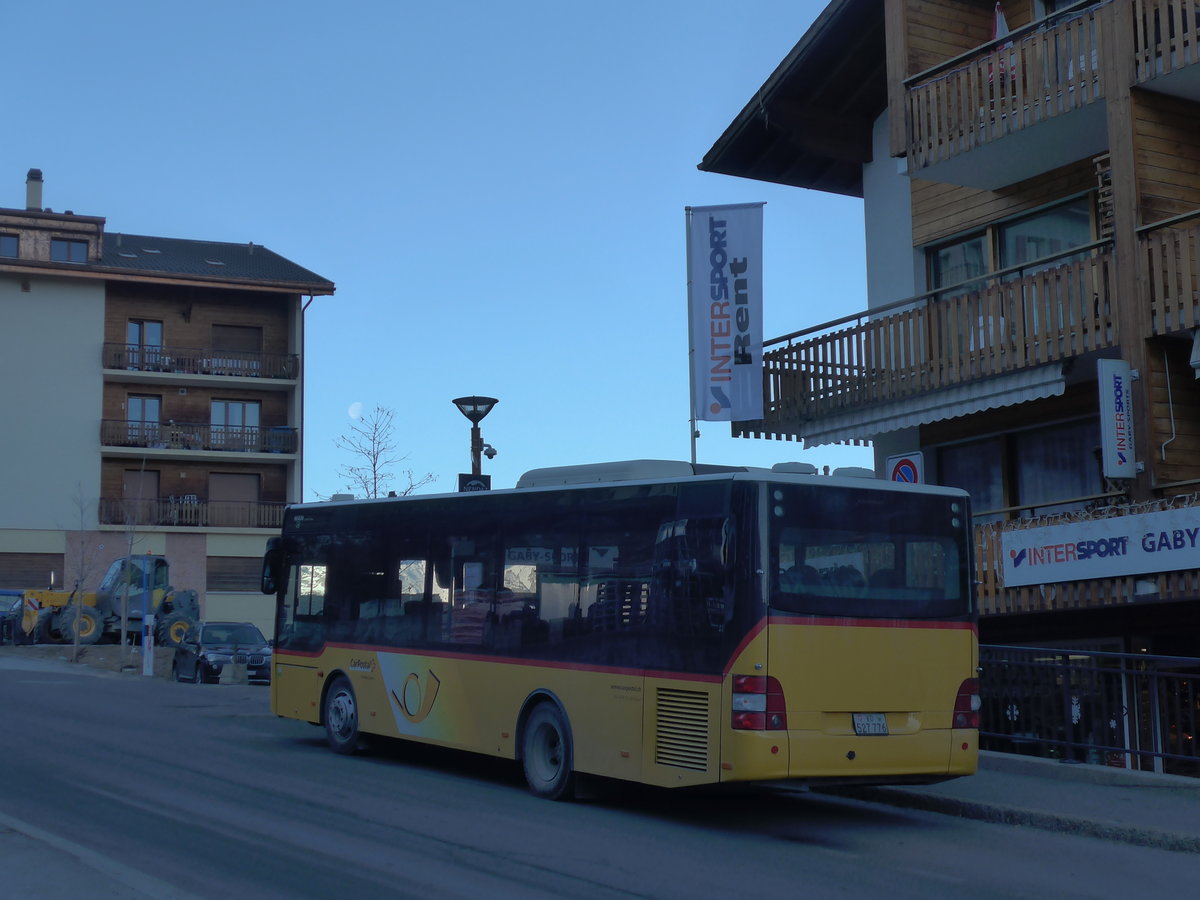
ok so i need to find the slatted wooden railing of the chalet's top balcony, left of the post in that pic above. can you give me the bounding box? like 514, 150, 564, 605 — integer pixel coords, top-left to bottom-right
905, 0, 1099, 172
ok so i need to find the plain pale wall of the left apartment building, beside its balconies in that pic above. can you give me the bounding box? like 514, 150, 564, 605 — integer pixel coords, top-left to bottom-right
0, 275, 104, 532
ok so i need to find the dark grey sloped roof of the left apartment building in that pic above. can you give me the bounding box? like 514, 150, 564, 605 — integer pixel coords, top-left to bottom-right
100, 232, 334, 294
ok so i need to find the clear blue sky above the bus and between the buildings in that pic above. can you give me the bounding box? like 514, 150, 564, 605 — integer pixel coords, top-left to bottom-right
9, 0, 870, 499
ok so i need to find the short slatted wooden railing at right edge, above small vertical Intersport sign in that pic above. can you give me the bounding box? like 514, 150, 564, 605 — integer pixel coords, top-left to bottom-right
1138, 211, 1200, 335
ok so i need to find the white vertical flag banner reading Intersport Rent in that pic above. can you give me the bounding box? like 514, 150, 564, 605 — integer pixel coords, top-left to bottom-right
685, 203, 764, 422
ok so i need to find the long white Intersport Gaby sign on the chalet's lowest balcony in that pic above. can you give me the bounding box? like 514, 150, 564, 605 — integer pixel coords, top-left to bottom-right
1000, 506, 1200, 588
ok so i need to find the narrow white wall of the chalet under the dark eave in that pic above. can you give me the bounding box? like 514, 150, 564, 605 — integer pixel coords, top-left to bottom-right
863, 112, 925, 308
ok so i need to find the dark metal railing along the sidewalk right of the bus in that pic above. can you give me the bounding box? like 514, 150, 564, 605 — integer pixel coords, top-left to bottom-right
979, 646, 1200, 776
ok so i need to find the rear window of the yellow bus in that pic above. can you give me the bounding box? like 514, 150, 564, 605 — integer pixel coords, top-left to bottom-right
769, 485, 972, 618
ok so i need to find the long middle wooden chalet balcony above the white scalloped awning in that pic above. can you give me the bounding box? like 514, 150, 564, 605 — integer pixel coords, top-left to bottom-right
734, 241, 1116, 440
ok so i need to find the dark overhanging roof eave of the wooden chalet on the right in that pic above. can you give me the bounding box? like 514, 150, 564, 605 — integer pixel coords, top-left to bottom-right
698, 0, 888, 197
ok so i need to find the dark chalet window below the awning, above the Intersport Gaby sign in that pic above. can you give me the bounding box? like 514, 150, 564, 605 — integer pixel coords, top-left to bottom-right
937, 419, 1104, 523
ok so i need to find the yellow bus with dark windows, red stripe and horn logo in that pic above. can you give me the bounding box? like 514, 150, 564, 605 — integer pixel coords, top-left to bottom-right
263, 460, 979, 799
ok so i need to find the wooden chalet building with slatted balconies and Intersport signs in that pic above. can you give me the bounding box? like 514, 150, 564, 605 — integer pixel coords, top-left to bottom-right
700, 0, 1200, 656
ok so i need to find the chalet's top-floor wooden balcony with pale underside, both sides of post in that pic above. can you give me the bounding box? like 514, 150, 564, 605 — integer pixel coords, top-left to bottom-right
905, 0, 1200, 190
